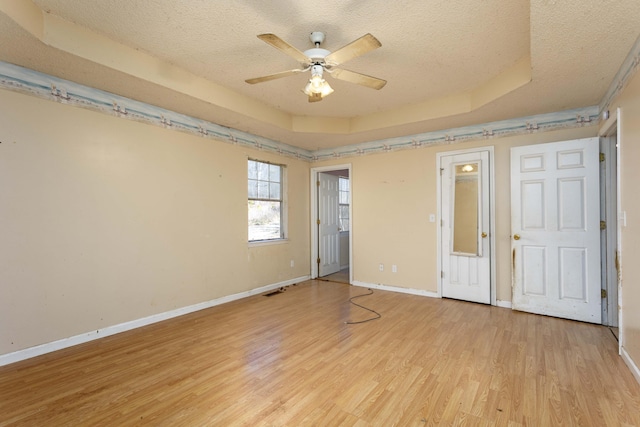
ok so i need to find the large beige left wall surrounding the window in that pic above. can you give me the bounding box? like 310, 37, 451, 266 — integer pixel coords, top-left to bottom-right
0, 90, 310, 355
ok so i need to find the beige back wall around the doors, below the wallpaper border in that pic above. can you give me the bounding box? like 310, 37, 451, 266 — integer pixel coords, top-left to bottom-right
313, 126, 597, 301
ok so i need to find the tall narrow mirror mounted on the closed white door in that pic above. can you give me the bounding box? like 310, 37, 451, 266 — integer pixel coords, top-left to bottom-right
452, 162, 482, 256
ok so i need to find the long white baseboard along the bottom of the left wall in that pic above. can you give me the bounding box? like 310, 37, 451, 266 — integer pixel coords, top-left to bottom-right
0, 276, 309, 366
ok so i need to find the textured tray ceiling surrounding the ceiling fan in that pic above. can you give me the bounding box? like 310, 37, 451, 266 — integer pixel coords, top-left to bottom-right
0, 0, 640, 150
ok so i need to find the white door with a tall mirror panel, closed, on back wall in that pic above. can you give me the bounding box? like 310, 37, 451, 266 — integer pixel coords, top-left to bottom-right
440, 151, 491, 304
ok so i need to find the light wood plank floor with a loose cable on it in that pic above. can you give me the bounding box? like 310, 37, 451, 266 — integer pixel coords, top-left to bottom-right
0, 281, 640, 426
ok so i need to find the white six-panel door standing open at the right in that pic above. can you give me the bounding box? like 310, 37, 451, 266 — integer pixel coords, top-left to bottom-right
511, 138, 601, 323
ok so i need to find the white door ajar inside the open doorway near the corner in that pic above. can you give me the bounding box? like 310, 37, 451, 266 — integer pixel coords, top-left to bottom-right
318, 173, 340, 277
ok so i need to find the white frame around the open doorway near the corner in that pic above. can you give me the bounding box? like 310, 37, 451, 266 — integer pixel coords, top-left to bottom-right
309, 163, 353, 284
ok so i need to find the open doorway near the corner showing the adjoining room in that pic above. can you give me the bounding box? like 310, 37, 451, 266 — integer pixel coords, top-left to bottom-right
311, 164, 353, 284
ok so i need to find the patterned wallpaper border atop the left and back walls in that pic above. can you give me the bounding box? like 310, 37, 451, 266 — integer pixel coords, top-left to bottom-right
0, 60, 600, 162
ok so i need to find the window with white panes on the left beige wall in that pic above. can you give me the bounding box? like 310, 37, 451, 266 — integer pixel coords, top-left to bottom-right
248, 159, 284, 242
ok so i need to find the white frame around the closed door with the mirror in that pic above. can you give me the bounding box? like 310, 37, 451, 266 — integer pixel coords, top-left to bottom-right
436, 149, 498, 307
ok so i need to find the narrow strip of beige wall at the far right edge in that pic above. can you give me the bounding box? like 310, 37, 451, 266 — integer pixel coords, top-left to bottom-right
609, 68, 640, 366
